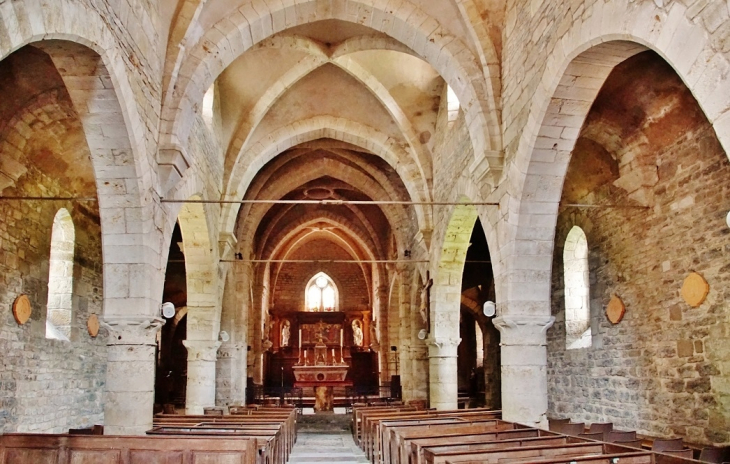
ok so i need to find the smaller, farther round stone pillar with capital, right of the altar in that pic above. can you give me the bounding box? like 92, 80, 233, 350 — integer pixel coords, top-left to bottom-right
428, 337, 461, 411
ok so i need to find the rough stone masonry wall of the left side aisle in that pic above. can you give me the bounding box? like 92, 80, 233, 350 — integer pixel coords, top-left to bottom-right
0, 167, 106, 433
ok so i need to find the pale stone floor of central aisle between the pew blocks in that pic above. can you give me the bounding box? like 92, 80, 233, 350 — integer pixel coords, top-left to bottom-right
288, 432, 370, 464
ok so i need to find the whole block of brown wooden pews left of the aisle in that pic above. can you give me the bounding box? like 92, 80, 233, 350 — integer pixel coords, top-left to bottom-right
0, 408, 296, 464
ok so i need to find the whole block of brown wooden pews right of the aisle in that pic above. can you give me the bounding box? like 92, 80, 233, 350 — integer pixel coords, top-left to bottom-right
353, 408, 697, 464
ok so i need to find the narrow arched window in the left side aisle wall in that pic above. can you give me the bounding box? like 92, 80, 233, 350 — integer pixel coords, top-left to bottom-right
46, 208, 76, 341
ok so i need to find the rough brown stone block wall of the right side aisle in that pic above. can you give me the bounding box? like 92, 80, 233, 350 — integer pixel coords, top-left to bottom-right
548, 52, 730, 444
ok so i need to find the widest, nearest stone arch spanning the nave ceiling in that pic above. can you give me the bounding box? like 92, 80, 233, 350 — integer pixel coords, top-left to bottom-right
163, 0, 501, 182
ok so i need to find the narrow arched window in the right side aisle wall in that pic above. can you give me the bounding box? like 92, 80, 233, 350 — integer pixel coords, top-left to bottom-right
563, 226, 591, 350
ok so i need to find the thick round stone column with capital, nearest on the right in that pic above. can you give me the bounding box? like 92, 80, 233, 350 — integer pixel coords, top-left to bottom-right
493, 315, 555, 428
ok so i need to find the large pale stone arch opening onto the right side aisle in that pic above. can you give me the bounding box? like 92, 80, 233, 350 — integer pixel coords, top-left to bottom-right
510, 0, 730, 304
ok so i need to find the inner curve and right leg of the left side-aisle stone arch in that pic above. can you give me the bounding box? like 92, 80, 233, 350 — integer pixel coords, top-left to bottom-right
4, 38, 158, 316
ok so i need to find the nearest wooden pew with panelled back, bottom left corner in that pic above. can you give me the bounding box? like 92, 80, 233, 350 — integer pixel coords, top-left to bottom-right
0, 433, 257, 464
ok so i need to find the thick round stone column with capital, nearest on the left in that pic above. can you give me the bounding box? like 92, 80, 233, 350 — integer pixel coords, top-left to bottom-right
102, 316, 165, 435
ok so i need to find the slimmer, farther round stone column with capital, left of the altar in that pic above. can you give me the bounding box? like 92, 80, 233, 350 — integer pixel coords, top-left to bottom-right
183, 340, 221, 414
